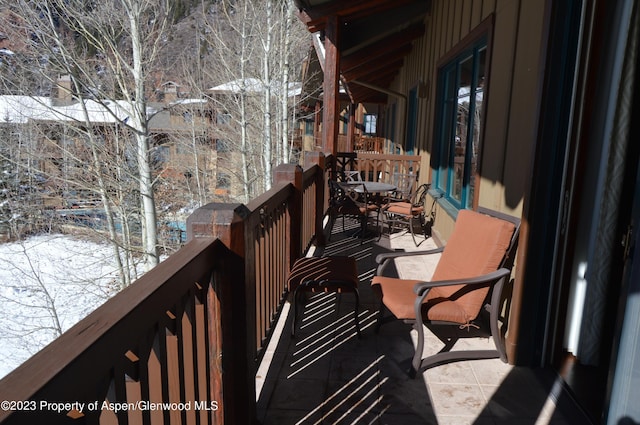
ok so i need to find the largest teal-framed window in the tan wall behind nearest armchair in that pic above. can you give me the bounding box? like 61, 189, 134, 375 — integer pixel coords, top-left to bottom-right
435, 37, 487, 209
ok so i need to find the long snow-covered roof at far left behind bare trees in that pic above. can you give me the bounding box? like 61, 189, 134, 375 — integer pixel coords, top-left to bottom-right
0, 96, 153, 124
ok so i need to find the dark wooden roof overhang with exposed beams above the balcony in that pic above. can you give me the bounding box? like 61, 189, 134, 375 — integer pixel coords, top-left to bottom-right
295, 0, 431, 103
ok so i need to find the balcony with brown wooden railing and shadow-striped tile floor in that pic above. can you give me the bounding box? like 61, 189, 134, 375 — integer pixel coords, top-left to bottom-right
0, 154, 584, 425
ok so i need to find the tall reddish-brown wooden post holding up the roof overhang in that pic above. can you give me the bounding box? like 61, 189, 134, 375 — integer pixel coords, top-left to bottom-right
322, 16, 340, 155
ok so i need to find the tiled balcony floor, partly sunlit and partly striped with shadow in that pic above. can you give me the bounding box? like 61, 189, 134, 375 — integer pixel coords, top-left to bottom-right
257, 226, 586, 425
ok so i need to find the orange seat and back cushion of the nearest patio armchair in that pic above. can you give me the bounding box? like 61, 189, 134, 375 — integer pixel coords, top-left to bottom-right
371, 210, 515, 324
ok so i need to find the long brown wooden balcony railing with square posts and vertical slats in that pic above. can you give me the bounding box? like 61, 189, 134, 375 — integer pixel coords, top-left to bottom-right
0, 154, 325, 425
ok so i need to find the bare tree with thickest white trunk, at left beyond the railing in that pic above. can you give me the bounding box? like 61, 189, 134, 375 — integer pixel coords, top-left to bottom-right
1, 0, 180, 269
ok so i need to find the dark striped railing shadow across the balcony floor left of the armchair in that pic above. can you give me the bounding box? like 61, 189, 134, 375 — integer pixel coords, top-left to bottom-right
258, 221, 437, 425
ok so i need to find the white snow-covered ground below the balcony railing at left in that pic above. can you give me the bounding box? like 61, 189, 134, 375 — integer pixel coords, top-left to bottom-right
0, 235, 118, 378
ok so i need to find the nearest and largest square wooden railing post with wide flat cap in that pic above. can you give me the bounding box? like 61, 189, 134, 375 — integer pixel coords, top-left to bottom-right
187, 203, 256, 424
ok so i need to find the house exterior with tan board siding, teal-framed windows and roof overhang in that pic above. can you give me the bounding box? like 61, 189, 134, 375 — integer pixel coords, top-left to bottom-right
296, 0, 640, 424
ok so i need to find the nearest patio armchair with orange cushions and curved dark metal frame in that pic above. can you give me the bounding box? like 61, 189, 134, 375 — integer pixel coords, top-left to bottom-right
371, 209, 520, 376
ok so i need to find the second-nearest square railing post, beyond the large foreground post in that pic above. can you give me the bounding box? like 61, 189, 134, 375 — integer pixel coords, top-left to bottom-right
273, 164, 304, 270
